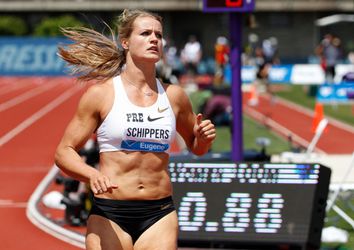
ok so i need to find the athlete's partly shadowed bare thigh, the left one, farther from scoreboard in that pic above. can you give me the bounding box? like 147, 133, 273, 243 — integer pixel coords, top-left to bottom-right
86, 215, 133, 250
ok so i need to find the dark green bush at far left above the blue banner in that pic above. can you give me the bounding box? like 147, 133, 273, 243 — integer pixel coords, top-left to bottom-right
0, 15, 28, 36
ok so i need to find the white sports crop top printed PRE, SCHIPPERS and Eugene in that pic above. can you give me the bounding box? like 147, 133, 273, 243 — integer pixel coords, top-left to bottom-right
97, 76, 176, 152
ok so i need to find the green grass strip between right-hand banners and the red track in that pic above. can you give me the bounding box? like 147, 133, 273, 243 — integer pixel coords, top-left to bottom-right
276, 85, 354, 126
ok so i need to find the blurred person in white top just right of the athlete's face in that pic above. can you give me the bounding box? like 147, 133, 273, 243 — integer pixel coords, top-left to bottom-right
181, 35, 202, 76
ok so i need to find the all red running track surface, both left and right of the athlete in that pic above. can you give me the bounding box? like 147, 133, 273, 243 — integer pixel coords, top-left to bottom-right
0, 77, 354, 250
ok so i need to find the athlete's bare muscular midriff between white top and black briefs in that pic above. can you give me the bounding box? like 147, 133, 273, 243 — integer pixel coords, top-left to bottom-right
97, 151, 172, 200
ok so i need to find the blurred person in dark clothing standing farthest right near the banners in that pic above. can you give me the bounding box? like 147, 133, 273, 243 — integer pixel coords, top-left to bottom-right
316, 34, 342, 83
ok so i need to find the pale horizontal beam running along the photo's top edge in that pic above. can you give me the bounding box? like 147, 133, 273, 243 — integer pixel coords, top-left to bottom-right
0, 0, 354, 12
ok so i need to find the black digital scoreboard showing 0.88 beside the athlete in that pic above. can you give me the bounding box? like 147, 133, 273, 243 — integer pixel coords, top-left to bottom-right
169, 161, 331, 250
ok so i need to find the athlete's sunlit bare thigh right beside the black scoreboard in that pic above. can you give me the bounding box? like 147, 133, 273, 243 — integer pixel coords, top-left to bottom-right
134, 211, 178, 250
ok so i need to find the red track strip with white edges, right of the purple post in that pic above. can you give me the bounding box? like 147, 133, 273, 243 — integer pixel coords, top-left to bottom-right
243, 94, 354, 154
